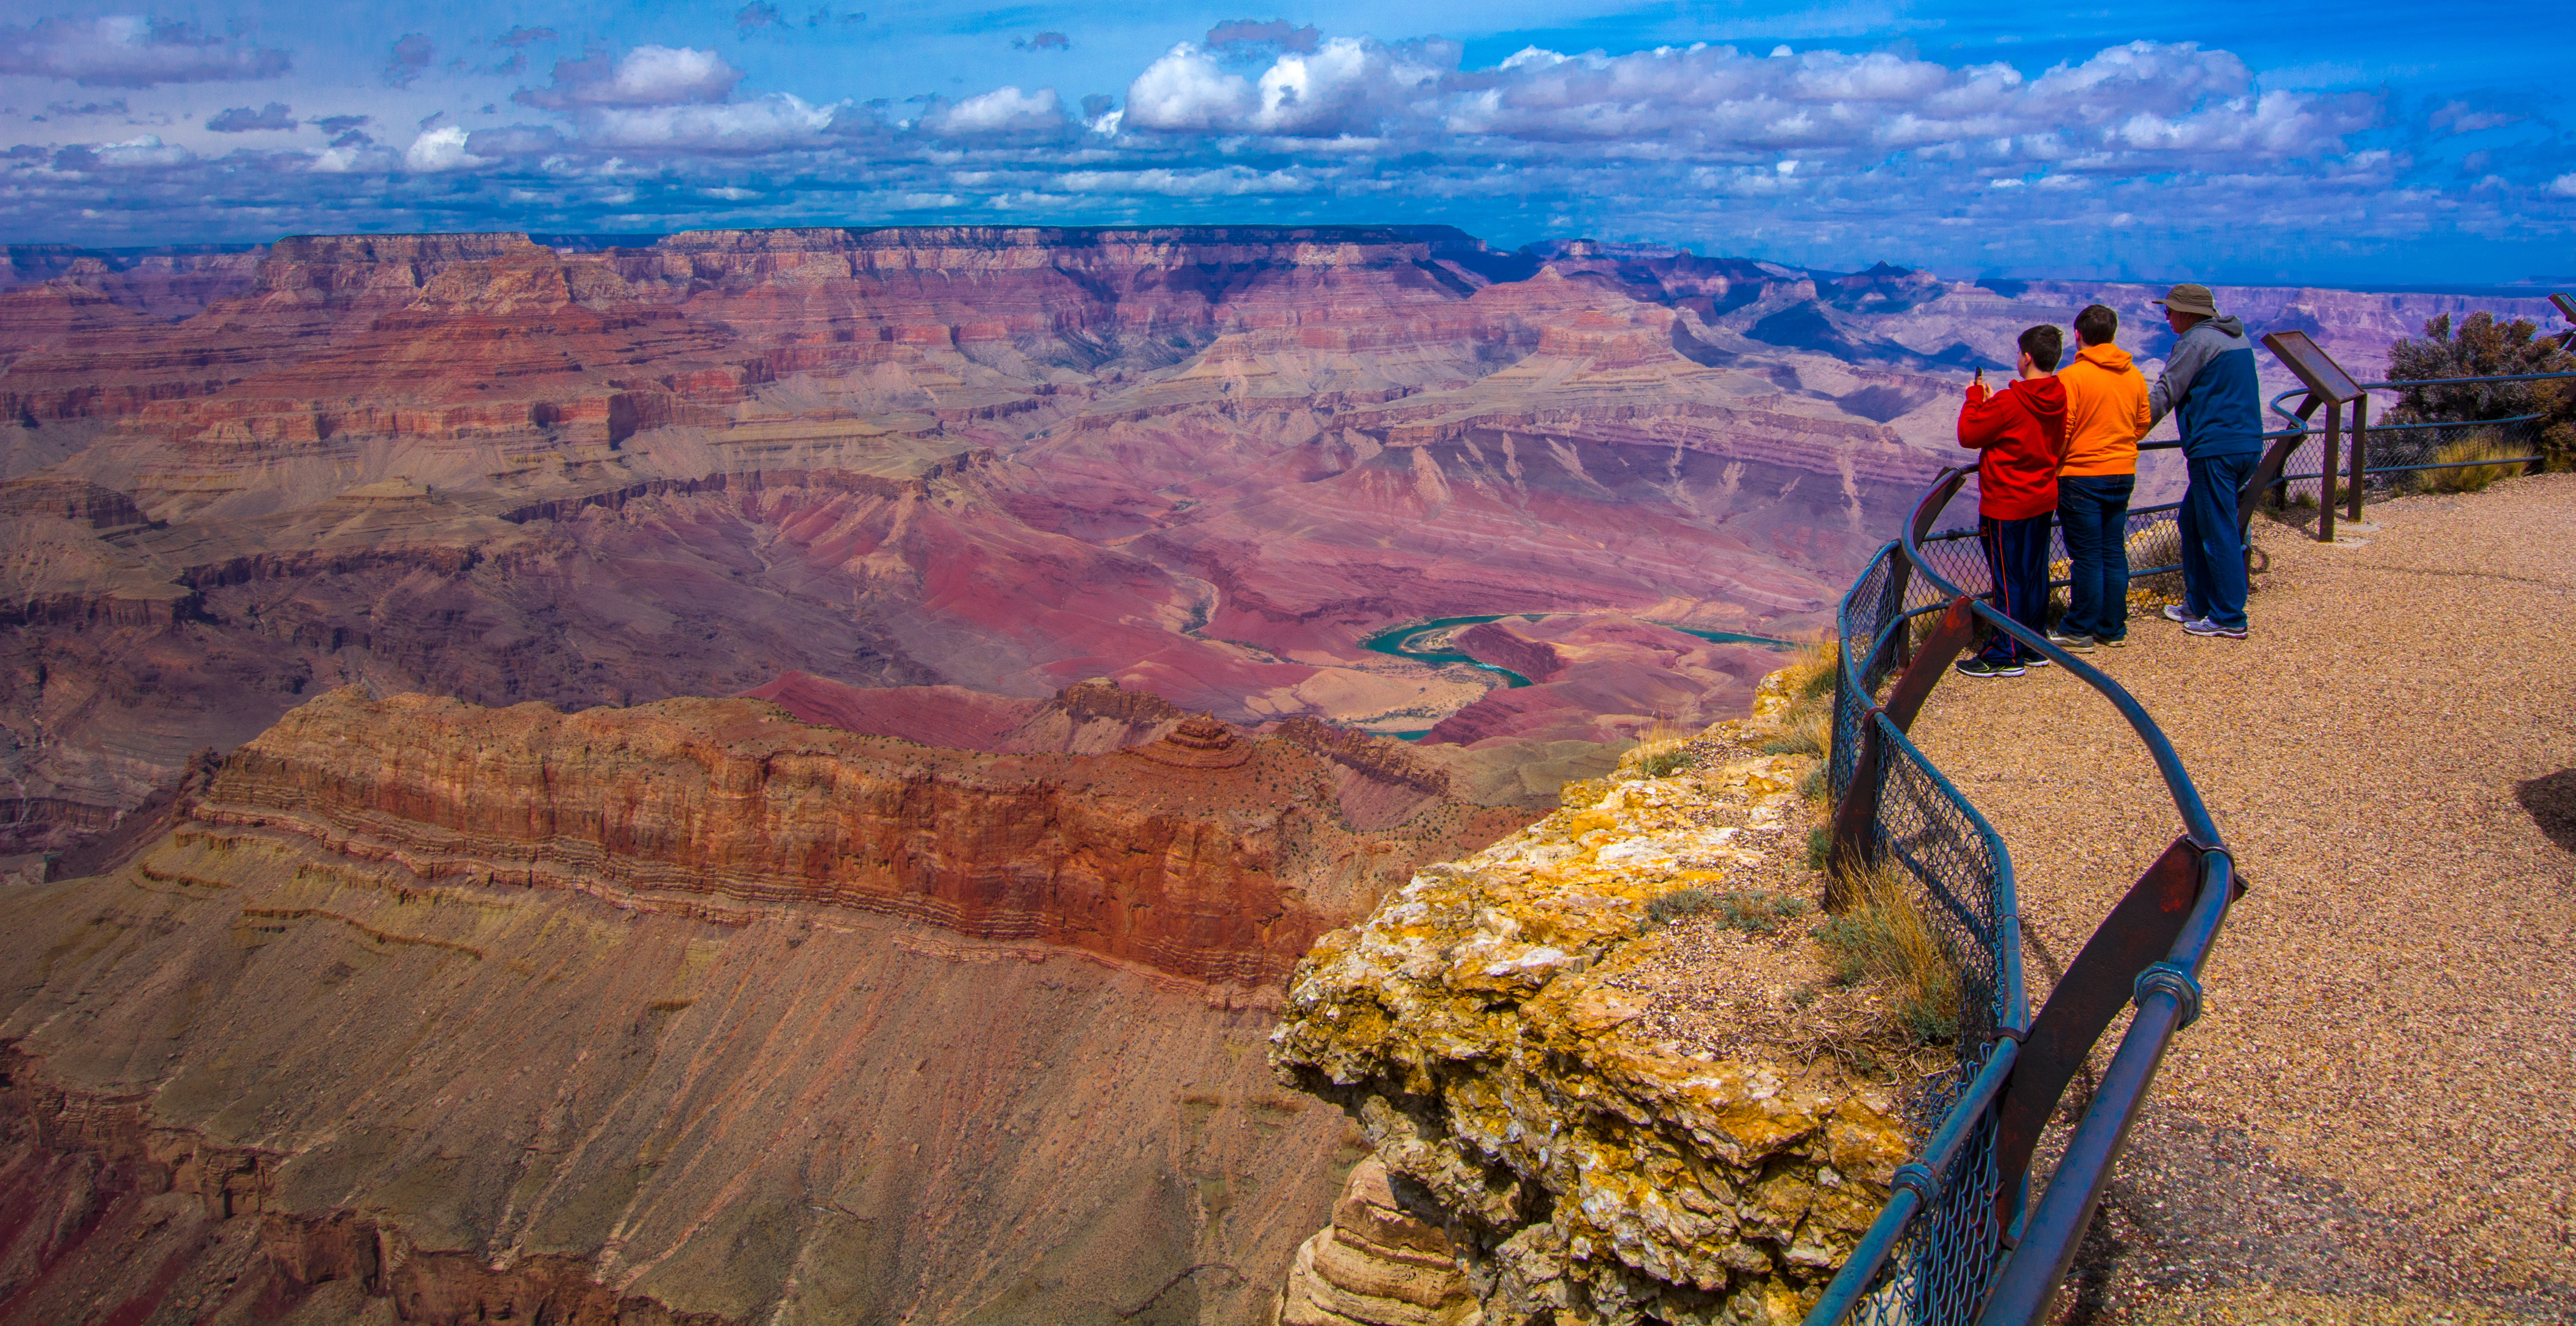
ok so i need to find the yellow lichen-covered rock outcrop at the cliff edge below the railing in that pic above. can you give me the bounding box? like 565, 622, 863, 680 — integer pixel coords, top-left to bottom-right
1272, 680, 1911, 1326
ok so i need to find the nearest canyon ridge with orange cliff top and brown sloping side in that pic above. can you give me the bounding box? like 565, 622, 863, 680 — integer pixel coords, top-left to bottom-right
0, 687, 1525, 1326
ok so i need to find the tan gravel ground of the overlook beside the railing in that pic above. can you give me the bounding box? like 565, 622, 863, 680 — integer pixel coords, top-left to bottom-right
1914, 474, 2576, 1323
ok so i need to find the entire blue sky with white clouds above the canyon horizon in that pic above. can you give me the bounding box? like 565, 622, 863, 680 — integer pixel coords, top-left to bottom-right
0, 0, 2576, 283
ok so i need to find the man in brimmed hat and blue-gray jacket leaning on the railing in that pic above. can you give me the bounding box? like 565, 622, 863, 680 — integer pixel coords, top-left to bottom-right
2146, 283, 2262, 641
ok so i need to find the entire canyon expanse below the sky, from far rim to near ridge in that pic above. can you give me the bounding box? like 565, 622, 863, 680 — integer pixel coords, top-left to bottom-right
0, 226, 2545, 1323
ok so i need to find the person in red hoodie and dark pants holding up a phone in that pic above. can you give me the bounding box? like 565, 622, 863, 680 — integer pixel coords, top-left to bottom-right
1958, 327, 2066, 677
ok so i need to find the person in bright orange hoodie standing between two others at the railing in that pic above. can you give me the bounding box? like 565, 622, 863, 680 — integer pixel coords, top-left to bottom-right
2048, 304, 2156, 654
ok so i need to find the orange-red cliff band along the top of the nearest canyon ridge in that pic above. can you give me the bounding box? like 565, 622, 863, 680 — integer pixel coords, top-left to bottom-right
193, 687, 1510, 984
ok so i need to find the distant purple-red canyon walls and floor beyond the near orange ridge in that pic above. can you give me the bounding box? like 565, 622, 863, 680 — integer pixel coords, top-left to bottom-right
0, 226, 2538, 850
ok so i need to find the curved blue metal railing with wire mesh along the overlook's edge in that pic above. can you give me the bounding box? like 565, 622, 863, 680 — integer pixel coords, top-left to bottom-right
1806, 468, 2246, 1326
